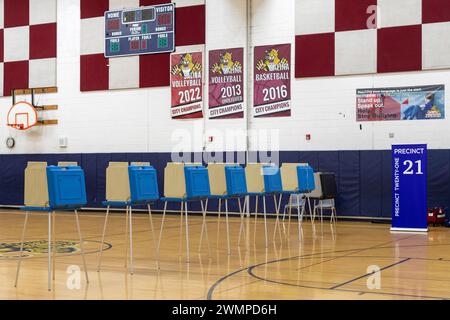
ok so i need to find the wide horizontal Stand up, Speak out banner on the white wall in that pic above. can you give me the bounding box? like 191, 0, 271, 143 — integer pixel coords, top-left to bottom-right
356, 85, 445, 121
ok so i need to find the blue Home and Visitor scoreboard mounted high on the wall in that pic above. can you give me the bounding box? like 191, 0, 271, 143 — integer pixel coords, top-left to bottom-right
105, 3, 175, 58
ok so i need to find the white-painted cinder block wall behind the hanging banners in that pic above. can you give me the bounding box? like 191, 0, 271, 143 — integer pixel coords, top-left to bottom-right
0, 0, 450, 154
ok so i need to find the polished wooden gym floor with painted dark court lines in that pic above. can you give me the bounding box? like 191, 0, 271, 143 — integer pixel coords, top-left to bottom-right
0, 211, 450, 300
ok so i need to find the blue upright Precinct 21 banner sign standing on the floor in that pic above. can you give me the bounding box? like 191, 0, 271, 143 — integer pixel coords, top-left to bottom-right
391, 144, 428, 232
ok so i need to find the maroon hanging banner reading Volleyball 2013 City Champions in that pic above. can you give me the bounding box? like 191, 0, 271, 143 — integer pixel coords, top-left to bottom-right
209, 48, 244, 119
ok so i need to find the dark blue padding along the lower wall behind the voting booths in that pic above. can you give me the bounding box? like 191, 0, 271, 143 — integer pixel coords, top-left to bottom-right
0, 150, 450, 217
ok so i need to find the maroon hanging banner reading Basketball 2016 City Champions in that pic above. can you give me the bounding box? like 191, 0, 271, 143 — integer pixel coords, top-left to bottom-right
253, 44, 291, 118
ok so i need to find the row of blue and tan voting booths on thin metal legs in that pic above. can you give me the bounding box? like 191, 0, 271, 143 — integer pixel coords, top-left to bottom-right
16, 162, 336, 290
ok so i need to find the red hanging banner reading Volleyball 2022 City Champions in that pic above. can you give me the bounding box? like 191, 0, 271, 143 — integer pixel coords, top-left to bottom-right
170, 52, 203, 119
